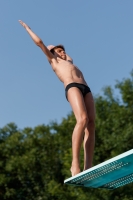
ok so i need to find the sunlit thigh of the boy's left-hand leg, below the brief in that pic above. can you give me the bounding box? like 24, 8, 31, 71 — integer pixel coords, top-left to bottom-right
67, 87, 87, 120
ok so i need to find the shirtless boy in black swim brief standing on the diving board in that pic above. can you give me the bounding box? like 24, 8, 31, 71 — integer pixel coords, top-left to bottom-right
19, 20, 95, 176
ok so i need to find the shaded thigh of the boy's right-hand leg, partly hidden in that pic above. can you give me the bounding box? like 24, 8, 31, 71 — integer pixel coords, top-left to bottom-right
84, 92, 96, 120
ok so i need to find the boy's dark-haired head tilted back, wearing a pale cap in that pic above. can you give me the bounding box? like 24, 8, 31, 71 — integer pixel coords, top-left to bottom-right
47, 45, 66, 60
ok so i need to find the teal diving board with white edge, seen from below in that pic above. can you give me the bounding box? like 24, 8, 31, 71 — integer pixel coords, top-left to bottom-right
64, 149, 133, 189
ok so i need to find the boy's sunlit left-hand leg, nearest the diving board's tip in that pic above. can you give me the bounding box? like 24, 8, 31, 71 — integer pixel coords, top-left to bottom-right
67, 87, 88, 176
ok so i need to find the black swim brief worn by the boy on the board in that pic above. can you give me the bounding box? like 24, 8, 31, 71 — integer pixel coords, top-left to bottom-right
65, 83, 91, 101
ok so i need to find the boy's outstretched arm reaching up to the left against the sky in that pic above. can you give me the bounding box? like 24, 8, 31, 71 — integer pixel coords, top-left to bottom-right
19, 20, 55, 63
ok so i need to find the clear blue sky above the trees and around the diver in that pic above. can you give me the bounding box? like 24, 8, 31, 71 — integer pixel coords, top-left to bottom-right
0, 0, 133, 129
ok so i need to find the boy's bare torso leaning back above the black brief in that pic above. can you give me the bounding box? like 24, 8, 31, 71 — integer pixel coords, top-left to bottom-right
51, 58, 87, 87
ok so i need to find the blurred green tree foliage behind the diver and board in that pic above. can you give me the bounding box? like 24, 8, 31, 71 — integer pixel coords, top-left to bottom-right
0, 71, 133, 200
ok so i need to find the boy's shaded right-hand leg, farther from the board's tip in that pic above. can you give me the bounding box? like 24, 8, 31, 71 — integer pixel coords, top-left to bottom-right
84, 93, 95, 170
